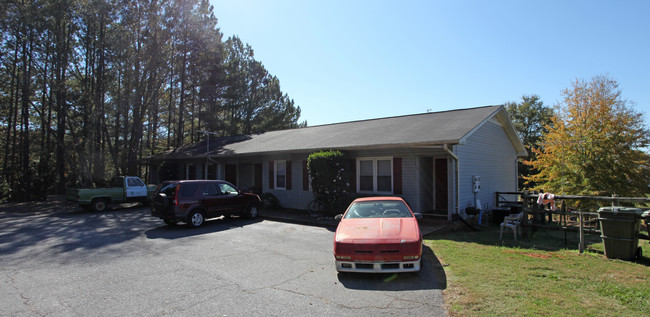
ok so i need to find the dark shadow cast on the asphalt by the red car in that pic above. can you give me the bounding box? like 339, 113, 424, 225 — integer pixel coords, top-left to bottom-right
338, 245, 447, 291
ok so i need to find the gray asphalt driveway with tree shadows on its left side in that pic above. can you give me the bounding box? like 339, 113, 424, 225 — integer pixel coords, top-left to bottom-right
0, 204, 446, 316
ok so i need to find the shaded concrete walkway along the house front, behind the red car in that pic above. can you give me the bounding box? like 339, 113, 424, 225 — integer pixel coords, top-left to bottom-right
260, 209, 449, 236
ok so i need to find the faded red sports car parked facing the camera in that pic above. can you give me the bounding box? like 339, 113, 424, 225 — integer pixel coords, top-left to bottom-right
334, 197, 422, 273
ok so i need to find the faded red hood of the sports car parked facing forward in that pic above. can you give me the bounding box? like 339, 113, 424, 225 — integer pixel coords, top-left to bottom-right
336, 218, 420, 243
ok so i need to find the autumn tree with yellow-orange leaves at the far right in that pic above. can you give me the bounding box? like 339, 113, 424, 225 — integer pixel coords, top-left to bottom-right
525, 76, 650, 196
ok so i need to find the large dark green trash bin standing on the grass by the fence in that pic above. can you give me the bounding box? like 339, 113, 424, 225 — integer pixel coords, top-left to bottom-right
598, 207, 643, 260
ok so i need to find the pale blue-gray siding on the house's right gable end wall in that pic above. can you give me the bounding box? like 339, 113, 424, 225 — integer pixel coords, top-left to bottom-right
457, 122, 517, 214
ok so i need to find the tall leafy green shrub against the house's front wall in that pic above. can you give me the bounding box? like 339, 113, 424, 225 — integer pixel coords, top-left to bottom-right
307, 150, 350, 216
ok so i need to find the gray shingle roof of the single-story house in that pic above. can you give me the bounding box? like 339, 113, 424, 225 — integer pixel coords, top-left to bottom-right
150, 106, 516, 160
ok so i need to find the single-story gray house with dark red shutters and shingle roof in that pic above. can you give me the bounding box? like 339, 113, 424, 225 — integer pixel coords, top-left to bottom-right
149, 106, 527, 220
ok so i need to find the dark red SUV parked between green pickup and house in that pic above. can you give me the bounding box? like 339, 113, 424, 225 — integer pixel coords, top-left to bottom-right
151, 180, 261, 228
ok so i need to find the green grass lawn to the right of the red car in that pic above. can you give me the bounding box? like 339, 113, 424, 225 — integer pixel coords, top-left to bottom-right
425, 227, 650, 316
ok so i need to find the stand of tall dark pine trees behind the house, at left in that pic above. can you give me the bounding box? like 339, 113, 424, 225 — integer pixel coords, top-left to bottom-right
0, 0, 306, 201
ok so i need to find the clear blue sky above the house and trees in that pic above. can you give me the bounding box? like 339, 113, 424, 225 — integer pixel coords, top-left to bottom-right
210, 0, 650, 125
